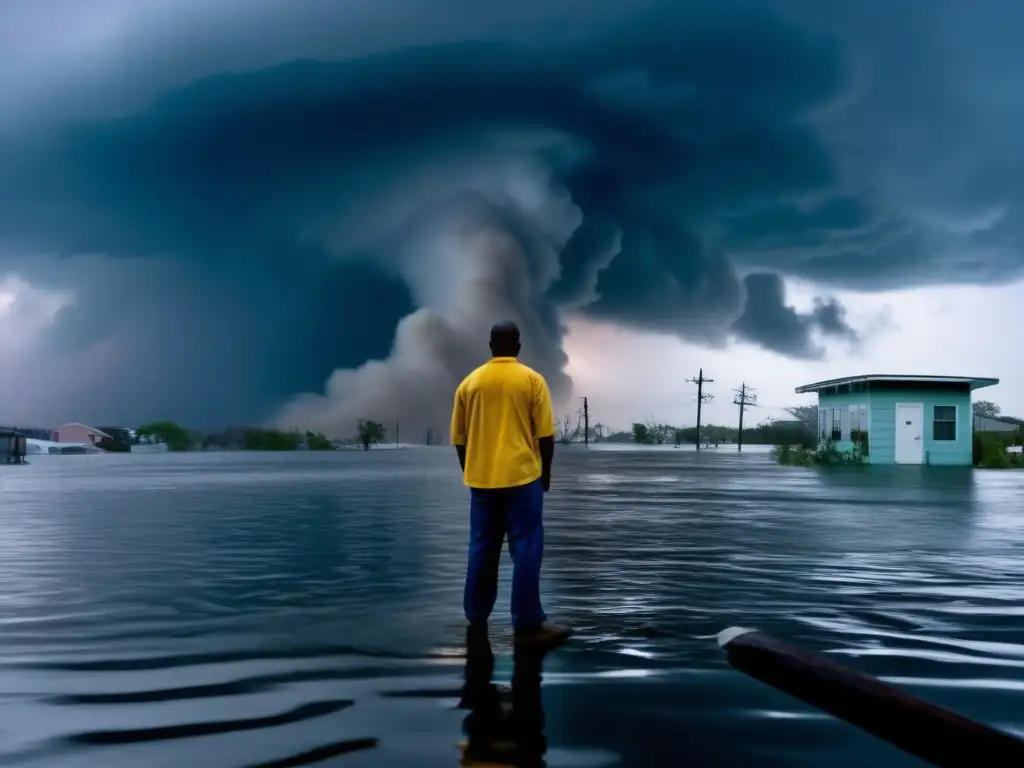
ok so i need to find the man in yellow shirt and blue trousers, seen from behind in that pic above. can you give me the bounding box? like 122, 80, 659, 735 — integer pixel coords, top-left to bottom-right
452, 323, 569, 646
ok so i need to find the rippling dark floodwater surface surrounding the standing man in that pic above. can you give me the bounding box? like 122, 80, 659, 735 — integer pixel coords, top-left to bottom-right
0, 449, 1024, 768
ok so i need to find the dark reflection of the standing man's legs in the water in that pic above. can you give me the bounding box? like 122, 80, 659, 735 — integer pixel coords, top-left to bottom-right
459, 629, 548, 768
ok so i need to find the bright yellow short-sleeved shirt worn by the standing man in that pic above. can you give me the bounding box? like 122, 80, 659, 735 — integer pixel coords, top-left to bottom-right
452, 357, 555, 488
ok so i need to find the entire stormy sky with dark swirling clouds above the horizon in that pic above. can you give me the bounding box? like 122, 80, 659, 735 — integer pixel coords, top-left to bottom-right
0, 0, 1024, 435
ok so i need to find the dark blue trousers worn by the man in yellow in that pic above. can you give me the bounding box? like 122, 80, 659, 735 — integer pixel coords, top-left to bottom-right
463, 480, 547, 629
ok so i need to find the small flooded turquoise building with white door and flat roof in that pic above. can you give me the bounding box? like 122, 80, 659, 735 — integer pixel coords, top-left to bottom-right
797, 375, 999, 467
